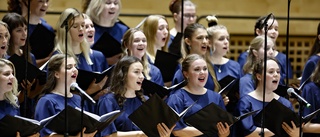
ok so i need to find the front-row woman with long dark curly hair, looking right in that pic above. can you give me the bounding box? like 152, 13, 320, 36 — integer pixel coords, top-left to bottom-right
97, 56, 173, 137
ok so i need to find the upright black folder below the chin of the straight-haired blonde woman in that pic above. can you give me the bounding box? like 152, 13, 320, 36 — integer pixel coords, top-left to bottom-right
154, 50, 180, 82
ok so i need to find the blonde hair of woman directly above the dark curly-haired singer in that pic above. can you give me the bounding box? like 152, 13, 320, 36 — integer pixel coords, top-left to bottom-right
121, 28, 151, 80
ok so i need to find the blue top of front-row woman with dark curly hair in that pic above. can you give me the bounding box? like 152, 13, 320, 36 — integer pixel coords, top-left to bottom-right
97, 93, 148, 136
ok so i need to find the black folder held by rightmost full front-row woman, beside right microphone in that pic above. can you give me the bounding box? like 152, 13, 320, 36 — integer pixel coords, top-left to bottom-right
254, 99, 320, 137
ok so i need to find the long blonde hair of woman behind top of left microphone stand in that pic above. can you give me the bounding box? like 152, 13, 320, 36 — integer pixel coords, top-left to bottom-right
55, 8, 93, 65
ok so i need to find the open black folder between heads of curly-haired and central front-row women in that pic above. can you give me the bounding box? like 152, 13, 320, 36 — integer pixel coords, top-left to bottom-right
142, 79, 187, 98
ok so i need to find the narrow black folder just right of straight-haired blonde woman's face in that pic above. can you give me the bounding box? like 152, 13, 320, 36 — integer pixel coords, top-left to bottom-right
169, 32, 182, 58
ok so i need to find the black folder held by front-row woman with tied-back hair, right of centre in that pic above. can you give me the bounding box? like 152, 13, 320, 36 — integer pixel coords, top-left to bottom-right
184, 103, 257, 136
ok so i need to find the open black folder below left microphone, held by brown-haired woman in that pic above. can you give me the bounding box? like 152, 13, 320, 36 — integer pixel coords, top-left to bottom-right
45, 106, 123, 136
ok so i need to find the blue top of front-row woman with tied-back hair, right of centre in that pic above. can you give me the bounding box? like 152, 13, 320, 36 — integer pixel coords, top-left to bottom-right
166, 89, 226, 136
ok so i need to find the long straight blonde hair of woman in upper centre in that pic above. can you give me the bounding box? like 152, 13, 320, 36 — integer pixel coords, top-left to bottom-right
143, 15, 170, 62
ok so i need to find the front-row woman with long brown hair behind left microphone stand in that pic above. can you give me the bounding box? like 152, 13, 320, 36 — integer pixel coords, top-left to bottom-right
35, 54, 96, 137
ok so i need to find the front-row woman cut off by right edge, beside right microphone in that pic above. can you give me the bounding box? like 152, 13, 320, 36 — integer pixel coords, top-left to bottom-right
302, 62, 320, 137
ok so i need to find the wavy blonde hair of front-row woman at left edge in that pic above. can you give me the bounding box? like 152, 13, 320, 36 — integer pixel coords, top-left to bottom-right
0, 58, 19, 108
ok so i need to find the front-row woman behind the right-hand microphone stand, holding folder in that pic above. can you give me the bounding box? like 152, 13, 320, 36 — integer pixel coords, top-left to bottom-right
233, 58, 299, 137
